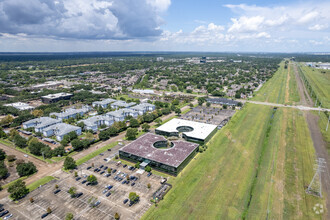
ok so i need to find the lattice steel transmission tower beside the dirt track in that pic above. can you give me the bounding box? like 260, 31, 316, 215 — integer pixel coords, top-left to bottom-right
306, 158, 326, 198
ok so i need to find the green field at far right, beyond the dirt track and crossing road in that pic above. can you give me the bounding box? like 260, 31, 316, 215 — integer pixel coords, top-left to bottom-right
299, 64, 330, 108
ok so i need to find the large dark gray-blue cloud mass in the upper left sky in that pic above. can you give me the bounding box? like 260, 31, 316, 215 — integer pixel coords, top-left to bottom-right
0, 0, 171, 39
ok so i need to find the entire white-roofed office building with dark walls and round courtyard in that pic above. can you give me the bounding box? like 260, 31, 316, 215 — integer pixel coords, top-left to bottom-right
155, 118, 217, 143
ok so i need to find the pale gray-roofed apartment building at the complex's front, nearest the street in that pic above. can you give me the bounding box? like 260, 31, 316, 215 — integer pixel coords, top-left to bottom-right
42, 123, 81, 141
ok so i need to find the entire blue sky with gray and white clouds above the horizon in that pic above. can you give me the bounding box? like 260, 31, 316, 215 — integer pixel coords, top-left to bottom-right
0, 0, 330, 52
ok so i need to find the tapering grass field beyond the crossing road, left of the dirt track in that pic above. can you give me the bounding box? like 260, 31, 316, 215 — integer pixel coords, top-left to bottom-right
252, 62, 300, 105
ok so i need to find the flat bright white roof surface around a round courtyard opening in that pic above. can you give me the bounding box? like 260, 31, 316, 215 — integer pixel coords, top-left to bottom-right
156, 118, 217, 140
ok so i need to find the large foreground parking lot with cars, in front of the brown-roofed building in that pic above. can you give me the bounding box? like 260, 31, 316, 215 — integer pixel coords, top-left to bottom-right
0, 149, 161, 219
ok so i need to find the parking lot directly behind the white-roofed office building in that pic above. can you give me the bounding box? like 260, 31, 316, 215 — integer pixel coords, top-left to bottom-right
180, 106, 235, 125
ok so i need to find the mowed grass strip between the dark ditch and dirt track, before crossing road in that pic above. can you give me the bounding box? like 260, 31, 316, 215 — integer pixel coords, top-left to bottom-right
247, 108, 325, 219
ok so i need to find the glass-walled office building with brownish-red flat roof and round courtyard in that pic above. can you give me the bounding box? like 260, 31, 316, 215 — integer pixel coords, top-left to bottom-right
119, 133, 199, 175
